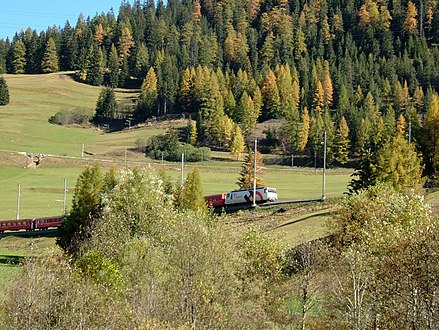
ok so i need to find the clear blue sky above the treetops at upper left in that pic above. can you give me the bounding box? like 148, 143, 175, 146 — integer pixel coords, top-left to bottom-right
0, 0, 124, 39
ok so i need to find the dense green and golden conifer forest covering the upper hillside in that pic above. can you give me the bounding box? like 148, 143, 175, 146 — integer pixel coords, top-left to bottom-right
0, 0, 439, 173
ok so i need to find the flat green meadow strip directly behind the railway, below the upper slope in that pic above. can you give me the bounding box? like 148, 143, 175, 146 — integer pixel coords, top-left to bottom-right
0, 153, 349, 220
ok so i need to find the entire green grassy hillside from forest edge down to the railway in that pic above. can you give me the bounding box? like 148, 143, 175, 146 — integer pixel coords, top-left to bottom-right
0, 73, 349, 219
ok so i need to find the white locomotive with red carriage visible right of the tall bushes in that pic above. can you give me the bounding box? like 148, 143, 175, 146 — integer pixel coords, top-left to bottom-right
204, 187, 278, 208
